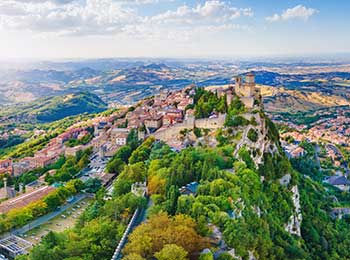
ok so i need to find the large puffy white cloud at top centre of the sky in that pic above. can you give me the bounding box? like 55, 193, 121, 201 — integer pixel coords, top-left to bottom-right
129, 0, 253, 42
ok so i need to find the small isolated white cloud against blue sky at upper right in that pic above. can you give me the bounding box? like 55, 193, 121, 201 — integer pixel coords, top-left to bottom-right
265, 5, 318, 22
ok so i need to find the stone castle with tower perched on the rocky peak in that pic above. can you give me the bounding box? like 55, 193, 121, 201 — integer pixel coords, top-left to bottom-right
235, 72, 261, 108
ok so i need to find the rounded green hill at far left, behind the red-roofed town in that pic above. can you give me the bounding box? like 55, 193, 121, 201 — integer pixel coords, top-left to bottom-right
0, 92, 107, 123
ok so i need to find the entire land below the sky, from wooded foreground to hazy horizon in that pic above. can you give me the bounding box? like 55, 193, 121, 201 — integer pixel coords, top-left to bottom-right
0, 63, 350, 260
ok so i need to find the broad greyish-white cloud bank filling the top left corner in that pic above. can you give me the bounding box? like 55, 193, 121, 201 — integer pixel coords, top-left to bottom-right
0, 0, 137, 35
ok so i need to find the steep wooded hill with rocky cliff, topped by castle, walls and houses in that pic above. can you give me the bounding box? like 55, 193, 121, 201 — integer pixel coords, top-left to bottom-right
13, 71, 350, 260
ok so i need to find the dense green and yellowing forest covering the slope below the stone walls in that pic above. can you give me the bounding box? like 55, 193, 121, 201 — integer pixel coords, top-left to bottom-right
19, 124, 350, 260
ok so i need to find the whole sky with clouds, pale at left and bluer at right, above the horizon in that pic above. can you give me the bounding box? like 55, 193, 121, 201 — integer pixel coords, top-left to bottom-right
0, 0, 350, 58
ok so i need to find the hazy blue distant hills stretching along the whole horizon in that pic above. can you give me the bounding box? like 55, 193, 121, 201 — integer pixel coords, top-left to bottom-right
0, 59, 350, 111
